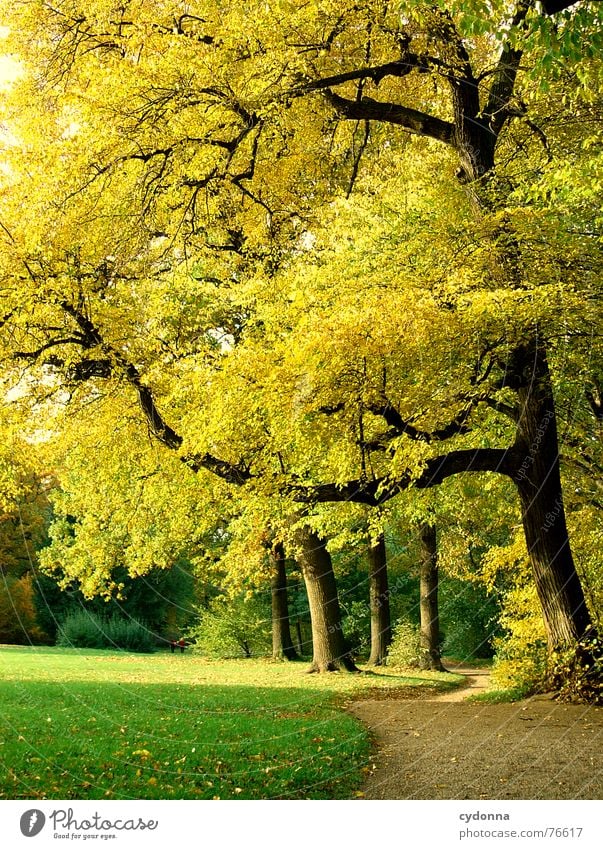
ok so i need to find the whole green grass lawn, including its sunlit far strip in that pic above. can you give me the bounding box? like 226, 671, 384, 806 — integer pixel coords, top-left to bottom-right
0, 646, 459, 799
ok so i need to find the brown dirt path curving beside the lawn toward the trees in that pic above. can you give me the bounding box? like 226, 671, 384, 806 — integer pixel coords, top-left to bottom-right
350, 666, 603, 799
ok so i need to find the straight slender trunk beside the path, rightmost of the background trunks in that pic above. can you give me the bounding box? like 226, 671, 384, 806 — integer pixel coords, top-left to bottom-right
419, 522, 445, 672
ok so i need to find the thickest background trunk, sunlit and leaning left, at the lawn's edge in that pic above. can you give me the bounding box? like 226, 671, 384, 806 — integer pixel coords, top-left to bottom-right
297, 528, 358, 672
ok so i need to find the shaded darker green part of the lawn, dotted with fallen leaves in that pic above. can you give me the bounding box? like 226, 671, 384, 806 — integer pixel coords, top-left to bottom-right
0, 681, 369, 799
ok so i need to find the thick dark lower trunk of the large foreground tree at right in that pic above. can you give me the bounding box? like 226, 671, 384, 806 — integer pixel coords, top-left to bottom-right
509, 342, 601, 700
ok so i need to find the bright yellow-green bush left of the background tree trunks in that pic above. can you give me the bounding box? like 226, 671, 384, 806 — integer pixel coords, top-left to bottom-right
186, 598, 272, 660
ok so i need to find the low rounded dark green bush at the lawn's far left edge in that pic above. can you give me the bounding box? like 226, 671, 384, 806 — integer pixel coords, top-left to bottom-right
57, 610, 155, 652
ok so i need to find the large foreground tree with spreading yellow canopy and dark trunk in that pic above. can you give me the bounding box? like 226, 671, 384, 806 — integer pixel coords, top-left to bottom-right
0, 0, 603, 696
